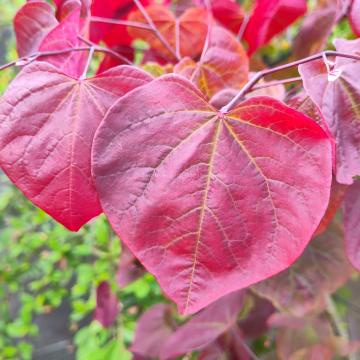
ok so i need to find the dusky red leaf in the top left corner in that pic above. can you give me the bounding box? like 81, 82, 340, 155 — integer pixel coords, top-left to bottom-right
14, 1, 58, 57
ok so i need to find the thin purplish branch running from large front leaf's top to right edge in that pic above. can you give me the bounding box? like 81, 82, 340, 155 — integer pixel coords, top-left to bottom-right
220, 51, 360, 113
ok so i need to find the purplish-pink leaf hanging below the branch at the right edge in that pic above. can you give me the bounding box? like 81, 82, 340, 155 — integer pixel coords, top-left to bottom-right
299, 40, 360, 184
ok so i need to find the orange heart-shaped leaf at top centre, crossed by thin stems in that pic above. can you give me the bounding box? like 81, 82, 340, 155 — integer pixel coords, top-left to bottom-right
128, 5, 208, 60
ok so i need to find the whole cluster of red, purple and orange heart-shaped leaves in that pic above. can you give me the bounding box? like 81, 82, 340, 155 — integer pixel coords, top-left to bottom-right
0, 0, 360, 359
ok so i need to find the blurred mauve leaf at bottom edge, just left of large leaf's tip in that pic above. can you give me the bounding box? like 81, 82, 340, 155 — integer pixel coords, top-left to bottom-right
131, 304, 175, 358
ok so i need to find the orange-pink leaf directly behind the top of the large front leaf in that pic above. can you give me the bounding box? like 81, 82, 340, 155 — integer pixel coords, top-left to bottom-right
174, 27, 249, 98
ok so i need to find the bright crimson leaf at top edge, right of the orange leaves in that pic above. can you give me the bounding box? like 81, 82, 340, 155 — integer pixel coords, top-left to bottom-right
244, 0, 306, 55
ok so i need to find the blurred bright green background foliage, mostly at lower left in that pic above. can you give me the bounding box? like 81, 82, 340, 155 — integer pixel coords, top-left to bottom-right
0, 0, 358, 360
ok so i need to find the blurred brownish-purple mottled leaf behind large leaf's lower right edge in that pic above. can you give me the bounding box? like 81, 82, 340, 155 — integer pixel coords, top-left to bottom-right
253, 225, 351, 316
